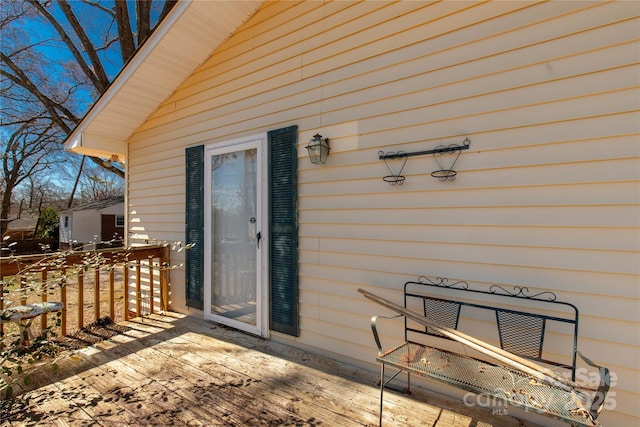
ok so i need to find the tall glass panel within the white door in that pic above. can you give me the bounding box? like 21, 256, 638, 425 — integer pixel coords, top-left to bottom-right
211, 148, 259, 325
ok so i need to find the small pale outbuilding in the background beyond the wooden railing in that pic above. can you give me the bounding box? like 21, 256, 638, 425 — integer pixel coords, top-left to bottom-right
60, 196, 125, 249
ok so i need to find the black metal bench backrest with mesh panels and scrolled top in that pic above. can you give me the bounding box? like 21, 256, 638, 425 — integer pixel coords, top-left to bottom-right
404, 276, 578, 380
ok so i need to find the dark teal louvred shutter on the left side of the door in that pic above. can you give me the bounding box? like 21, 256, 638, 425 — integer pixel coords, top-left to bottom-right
185, 145, 204, 310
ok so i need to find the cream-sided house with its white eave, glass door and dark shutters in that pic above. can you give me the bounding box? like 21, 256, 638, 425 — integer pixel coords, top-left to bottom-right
66, 1, 640, 426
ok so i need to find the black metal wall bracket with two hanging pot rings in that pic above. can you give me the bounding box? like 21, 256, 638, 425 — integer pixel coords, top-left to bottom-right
378, 138, 471, 185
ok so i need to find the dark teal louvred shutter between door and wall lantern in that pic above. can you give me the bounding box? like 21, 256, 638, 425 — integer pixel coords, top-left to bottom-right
268, 126, 300, 336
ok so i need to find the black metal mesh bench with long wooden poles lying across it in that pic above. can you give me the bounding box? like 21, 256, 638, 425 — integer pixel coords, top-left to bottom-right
359, 277, 610, 426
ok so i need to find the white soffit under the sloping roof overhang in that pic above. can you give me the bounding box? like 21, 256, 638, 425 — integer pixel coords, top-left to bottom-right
64, 0, 262, 160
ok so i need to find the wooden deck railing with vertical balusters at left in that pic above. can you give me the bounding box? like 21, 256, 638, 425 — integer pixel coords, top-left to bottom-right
0, 245, 169, 336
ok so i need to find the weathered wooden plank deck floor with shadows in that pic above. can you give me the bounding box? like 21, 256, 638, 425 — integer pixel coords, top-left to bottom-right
4, 314, 540, 427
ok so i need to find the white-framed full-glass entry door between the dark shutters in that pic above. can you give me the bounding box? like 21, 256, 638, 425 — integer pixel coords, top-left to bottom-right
204, 138, 268, 336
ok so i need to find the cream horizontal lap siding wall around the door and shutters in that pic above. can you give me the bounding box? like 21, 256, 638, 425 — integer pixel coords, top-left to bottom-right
125, 1, 640, 425
